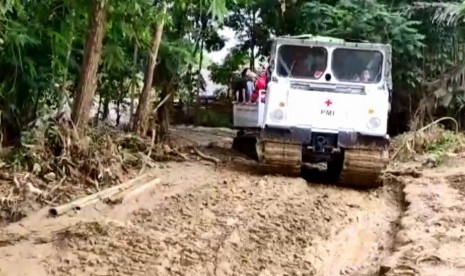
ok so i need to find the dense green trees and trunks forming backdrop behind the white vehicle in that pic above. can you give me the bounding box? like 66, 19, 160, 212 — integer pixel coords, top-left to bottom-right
0, 0, 465, 142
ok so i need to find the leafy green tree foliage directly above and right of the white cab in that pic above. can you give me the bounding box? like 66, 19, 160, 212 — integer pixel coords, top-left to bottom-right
296, 0, 425, 87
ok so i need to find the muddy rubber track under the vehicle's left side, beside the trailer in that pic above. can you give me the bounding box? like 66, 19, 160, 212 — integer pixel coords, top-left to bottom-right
257, 139, 302, 176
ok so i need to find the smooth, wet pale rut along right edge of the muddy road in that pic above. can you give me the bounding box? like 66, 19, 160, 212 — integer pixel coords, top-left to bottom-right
308, 172, 403, 276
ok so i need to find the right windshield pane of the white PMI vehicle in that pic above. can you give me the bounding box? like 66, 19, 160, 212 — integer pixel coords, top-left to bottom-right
331, 48, 383, 83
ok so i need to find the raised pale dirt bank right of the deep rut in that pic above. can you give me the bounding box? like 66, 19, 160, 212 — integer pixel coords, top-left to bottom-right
385, 158, 465, 276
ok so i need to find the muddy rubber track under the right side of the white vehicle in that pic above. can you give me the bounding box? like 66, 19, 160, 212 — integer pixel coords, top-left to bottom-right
339, 149, 389, 188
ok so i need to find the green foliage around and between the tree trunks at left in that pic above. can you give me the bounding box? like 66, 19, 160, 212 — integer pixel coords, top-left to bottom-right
0, 0, 226, 141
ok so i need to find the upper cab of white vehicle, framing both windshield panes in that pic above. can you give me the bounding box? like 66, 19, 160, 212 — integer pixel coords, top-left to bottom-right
269, 35, 392, 90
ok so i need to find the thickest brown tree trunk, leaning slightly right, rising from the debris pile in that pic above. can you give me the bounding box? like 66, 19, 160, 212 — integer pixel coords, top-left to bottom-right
71, 0, 108, 129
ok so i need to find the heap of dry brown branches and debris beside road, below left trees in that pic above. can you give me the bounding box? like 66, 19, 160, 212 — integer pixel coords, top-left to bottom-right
0, 118, 183, 223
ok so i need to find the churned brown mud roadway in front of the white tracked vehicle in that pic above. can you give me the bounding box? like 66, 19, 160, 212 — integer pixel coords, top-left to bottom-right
37, 162, 402, 276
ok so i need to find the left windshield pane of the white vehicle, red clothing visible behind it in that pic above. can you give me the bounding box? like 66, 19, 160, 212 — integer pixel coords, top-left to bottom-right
276, 45, 328, 79
